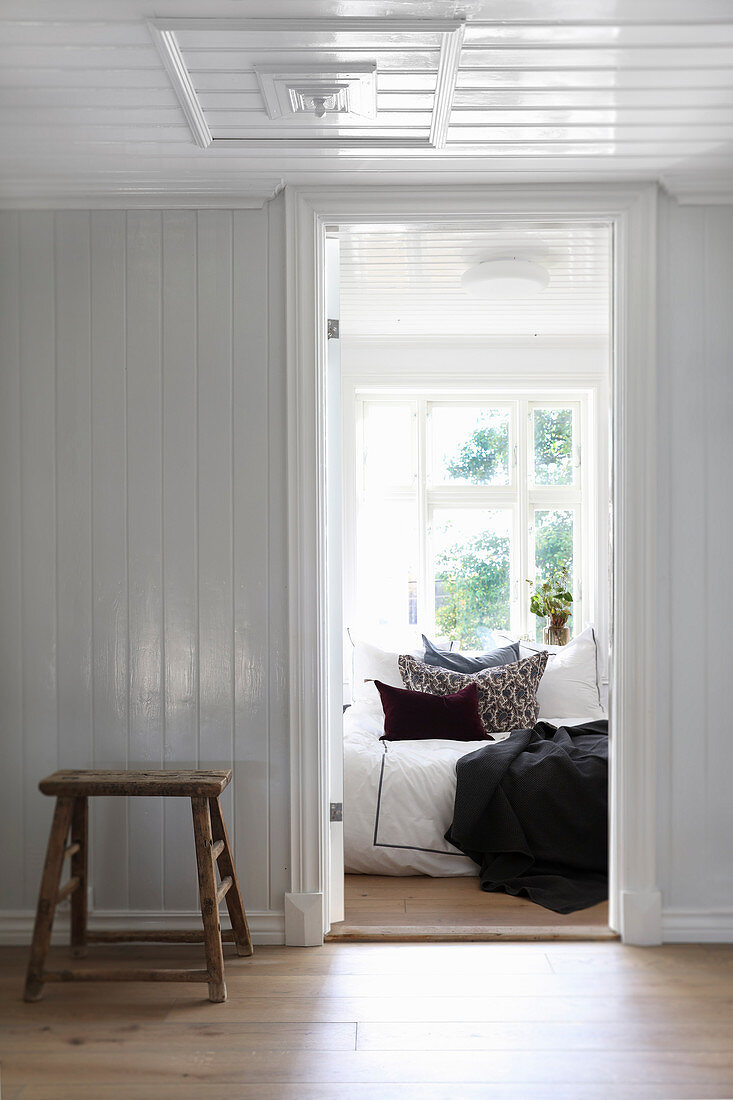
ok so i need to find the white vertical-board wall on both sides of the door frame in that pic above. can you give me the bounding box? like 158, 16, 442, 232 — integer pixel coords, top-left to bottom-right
0, 198, 733, 942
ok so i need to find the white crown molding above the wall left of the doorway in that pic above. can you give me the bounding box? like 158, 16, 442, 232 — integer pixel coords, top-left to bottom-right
0, 176, 284, 210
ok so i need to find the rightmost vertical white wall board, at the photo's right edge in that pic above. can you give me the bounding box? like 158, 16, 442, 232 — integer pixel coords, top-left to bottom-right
703, 206, 733, 912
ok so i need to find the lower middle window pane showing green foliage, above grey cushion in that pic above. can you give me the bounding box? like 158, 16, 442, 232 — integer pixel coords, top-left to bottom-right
431, 508, 512, 649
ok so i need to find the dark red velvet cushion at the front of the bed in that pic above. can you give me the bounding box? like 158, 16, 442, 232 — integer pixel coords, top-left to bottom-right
374, 680, 493, 741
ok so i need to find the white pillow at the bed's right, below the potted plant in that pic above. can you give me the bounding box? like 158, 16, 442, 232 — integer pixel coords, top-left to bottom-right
519, 626, 605, 722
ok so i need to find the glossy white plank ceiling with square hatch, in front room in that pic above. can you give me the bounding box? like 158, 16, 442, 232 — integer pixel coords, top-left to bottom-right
0, 0, 733, 198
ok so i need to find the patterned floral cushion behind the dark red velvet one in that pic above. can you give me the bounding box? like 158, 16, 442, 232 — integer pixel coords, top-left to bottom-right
398, 651, 547, 734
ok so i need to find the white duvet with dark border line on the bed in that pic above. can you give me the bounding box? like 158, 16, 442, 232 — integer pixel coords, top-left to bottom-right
343, 703, 578, 878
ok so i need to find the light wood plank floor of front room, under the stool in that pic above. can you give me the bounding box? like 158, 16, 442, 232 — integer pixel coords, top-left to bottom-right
0, 942, 733, 1100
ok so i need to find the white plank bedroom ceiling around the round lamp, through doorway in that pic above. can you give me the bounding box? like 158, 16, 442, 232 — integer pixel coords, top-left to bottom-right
340, 219, 610, 338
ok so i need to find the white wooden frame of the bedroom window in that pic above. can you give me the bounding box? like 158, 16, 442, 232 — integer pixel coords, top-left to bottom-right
342, 385, 594, 646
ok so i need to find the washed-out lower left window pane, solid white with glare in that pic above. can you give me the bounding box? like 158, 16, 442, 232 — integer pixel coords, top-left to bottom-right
357, 501, 417, 646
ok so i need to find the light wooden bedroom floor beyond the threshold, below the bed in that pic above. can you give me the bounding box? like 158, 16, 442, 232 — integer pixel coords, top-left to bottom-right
327, 875, 615, 942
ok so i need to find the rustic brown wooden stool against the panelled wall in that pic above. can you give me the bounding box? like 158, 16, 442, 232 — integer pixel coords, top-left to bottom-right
23, 771, 252, 1001
